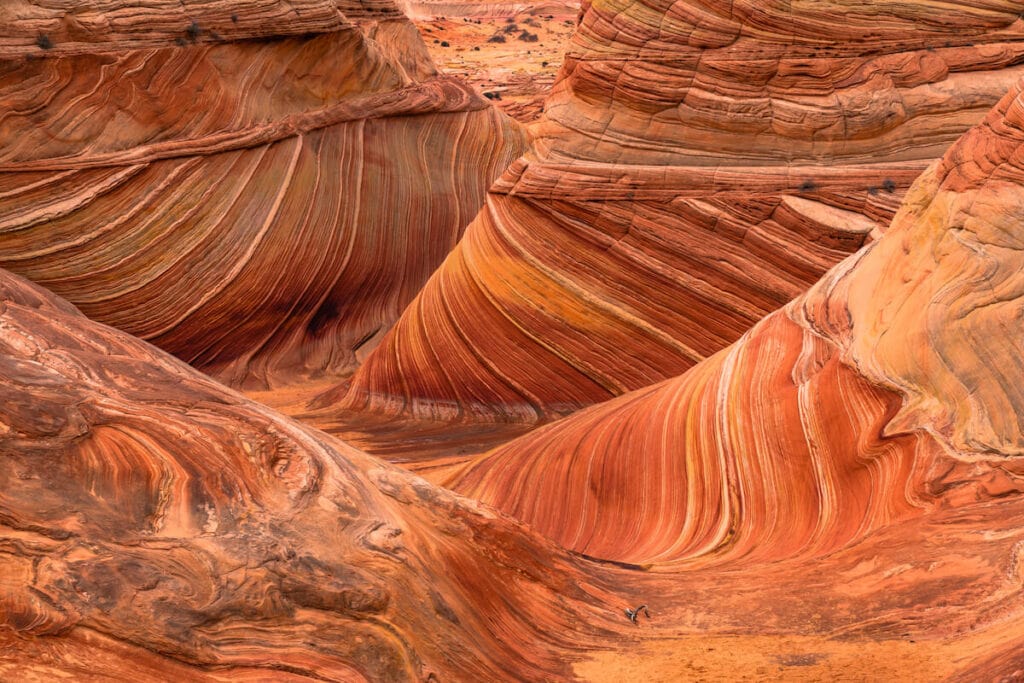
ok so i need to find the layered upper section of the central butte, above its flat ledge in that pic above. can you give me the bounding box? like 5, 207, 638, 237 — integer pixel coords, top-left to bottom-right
539, 0, 1024, 165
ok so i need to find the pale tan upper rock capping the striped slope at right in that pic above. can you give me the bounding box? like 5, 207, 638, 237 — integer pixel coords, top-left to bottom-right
815, 82, 1024, 462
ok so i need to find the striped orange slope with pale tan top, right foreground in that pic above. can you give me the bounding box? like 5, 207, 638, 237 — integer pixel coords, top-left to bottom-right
444, 77, 1024, 681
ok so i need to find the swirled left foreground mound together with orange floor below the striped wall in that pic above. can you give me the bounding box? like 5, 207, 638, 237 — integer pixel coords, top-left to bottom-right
8, 259, 1024, 681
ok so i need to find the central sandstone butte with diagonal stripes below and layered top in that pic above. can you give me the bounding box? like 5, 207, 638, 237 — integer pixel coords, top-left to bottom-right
339, 0, 1024, 422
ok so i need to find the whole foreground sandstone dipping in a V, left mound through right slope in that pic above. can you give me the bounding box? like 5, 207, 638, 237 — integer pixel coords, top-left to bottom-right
6, 89, 1024, 681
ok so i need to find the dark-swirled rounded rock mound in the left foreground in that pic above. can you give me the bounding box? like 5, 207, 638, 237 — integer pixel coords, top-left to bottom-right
0, 271, 614, 681
